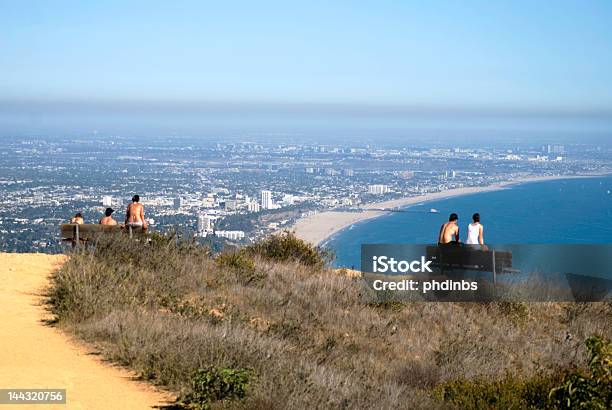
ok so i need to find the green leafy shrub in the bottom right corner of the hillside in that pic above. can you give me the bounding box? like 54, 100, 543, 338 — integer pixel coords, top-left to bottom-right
550, 337, 612, 409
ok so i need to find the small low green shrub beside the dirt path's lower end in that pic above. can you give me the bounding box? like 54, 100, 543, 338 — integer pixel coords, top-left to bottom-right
183, 367, 253, 409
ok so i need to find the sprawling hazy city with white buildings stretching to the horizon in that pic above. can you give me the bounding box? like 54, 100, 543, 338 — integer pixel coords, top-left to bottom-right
0, 136, 612, 252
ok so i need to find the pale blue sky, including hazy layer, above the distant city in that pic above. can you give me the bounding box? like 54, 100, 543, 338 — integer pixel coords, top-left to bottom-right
0, 0, 612, 136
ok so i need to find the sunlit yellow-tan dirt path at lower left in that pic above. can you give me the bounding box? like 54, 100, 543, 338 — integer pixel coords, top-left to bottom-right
0, 254, 172, 410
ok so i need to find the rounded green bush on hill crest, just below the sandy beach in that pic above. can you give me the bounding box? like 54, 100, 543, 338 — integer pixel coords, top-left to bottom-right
245, 231, 331, 269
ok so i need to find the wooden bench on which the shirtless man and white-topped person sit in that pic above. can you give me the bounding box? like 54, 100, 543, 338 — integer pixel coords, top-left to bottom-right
426, 245, 513, 283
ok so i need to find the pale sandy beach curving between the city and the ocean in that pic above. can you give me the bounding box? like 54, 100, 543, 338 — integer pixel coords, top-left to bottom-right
292, 174, 607, 246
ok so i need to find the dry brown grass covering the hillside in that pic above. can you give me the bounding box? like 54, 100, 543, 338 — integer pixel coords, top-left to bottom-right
50, 232, 612, 409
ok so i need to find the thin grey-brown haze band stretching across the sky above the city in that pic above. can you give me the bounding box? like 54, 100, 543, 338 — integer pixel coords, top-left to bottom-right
0, 98, 612, 119
